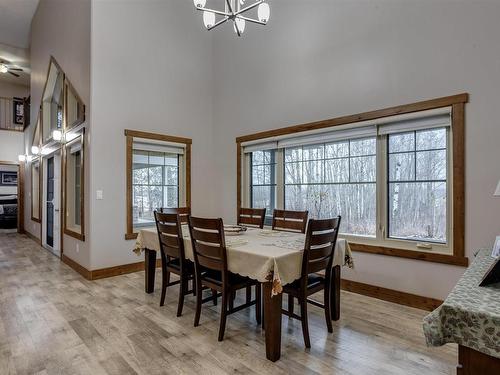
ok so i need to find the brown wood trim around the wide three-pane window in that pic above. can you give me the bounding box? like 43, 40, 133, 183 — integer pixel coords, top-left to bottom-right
236, 93, 469, 267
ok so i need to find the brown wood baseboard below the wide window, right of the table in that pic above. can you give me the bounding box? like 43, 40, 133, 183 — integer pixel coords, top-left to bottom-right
340, 279, 443, 311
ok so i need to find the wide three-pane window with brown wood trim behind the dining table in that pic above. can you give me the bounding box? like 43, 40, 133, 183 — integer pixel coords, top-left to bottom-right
237, 95, 467, 265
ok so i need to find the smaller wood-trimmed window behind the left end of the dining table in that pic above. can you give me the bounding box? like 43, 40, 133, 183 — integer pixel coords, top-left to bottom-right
125, 130, 191, 239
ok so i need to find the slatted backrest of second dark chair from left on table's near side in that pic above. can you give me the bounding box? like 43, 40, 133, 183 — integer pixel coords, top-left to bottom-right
188, 216, 227, 274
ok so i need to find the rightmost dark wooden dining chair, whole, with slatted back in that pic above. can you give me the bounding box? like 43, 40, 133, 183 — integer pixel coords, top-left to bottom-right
282, 216, 341, 348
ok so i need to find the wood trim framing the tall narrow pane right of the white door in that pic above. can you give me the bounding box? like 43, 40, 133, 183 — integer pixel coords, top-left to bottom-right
62, 132, 85, 241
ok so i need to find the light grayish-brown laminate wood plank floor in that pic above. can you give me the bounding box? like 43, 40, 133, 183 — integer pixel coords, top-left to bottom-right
0, 234, 457, 375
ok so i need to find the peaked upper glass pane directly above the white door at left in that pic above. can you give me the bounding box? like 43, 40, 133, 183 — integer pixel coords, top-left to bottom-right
41, 59, 64, 143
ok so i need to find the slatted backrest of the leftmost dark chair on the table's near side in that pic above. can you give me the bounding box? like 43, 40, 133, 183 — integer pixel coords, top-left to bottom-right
155, 211, 186, 263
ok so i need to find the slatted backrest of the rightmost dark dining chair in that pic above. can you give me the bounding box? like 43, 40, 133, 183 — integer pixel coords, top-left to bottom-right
302, 216, 341, 277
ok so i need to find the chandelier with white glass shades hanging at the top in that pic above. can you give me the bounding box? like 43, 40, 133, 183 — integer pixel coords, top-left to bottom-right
193, 0, 271, 36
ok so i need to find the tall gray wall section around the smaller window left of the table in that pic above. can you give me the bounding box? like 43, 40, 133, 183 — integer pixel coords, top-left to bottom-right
89, 0, 215, 269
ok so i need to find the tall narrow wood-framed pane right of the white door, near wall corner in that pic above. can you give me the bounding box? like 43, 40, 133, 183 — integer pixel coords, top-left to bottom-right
64, 131, 85, 241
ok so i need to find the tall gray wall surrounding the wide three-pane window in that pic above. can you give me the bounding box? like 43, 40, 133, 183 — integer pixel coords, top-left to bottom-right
213, 0, 500, 298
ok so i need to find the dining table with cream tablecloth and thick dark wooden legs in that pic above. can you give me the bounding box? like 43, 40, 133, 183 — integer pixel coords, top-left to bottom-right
134, 224, 354, 361
